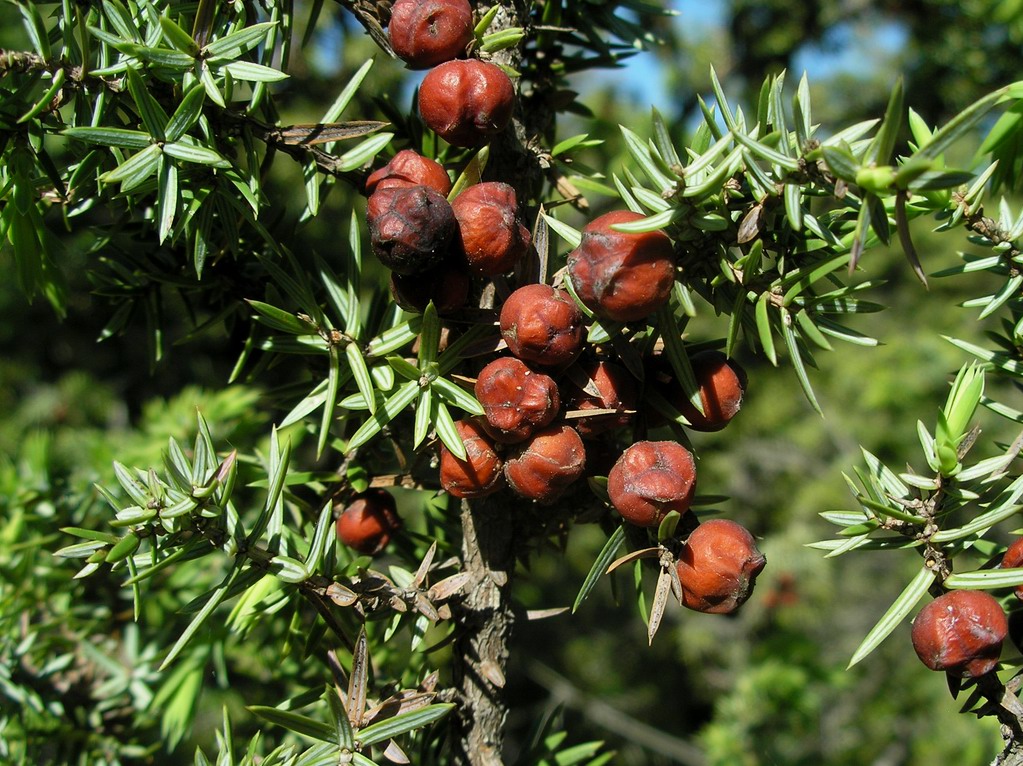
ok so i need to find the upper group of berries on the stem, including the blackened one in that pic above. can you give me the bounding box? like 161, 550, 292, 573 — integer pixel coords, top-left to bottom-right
366, 0, 519, 314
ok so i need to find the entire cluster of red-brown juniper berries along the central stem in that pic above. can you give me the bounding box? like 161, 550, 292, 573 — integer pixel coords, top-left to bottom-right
338, 0, 765, 613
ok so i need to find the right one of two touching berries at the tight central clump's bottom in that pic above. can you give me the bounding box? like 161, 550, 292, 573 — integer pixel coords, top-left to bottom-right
504, 425, 586, 503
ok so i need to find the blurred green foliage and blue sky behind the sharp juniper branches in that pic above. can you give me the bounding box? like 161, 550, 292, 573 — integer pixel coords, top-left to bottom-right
0, 0, 1023, 766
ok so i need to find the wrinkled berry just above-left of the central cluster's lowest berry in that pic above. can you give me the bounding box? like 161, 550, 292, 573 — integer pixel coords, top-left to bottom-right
608, 435, 697, 527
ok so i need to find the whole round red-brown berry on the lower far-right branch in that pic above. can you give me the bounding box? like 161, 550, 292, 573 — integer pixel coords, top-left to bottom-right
911, 590, 1009, 678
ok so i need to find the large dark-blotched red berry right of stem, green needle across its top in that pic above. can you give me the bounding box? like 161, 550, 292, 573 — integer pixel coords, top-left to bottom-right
568, 210, 675, 322
